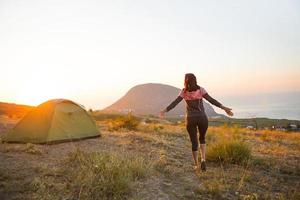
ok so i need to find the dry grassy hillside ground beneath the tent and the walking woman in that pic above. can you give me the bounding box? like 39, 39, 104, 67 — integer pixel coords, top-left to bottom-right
0, 116, 300, 200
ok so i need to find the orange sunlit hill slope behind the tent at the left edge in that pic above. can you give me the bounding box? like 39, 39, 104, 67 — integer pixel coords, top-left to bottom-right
0, 102, 33, 117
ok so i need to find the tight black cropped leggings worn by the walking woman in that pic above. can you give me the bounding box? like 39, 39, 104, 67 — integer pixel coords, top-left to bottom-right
186, 115, 208, 151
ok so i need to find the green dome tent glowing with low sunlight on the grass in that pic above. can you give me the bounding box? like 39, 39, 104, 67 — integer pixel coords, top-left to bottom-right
2, 99, 100, 143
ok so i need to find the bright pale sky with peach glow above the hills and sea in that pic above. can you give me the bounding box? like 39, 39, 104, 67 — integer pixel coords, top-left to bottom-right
0, 0, 300, 109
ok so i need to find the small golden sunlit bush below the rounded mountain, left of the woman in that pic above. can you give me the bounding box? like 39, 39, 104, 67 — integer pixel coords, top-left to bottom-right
112, 114, 140, 130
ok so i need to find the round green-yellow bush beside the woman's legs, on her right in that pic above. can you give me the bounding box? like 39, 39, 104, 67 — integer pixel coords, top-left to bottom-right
207, 140, 251, 164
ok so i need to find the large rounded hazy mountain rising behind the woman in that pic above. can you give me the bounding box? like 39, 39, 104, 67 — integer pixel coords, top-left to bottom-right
104, 83, 223, 117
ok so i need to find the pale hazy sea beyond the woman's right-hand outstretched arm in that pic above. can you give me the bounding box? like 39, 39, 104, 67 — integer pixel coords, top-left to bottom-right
217, 91, 300, 120
